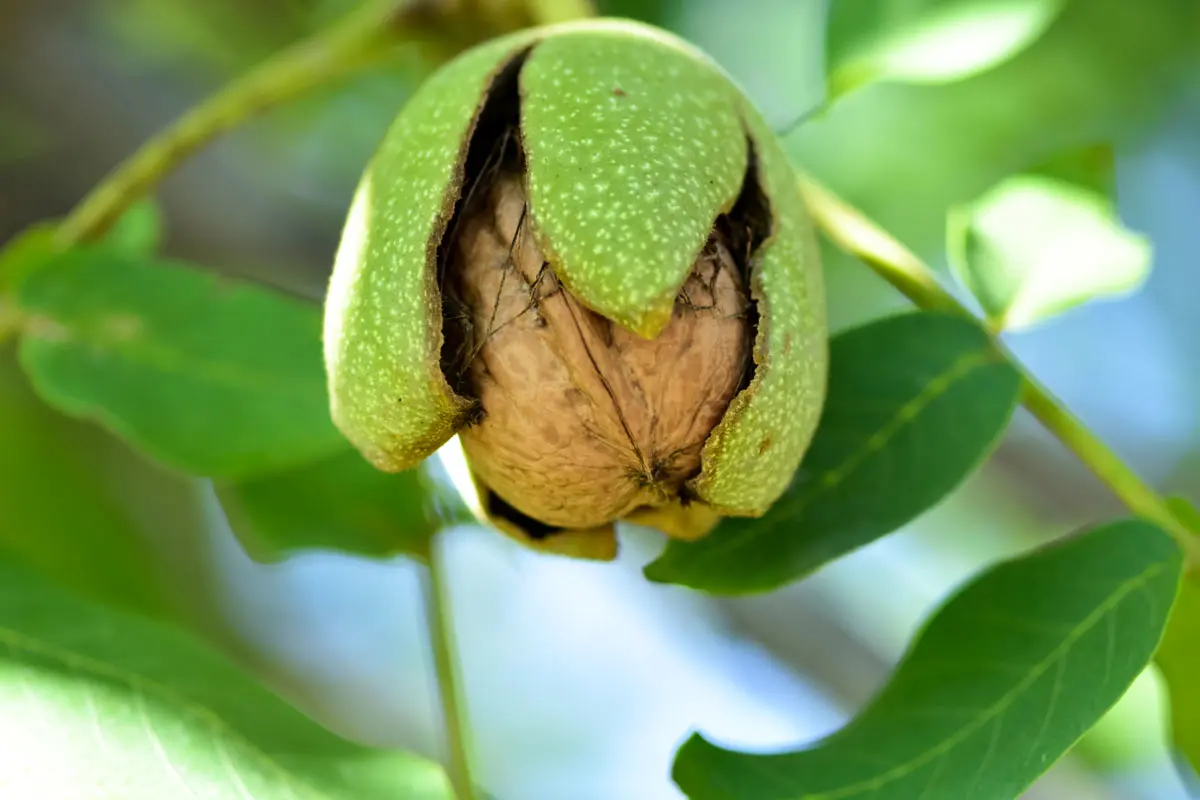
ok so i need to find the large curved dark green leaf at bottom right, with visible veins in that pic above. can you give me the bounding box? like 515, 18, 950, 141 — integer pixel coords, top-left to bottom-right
673, 521, 1183, 800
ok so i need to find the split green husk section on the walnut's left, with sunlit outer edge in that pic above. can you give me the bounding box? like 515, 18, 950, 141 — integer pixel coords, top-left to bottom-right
324, 34, 534, 471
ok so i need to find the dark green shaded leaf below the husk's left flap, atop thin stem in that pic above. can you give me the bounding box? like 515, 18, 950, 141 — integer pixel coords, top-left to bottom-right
218, 450, 438, 559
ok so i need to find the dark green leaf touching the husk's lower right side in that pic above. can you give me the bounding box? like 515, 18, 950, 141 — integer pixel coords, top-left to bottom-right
646, 312, 1020, 594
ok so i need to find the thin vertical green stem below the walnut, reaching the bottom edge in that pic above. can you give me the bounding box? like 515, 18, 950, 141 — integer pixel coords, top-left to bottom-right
425, 535, 476, 800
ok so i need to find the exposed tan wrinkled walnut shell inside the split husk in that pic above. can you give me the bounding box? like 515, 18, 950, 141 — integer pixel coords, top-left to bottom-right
443, 173, 754, 528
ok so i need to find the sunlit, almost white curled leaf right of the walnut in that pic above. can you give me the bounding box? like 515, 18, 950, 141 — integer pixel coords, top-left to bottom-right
947, 175, 1151, 330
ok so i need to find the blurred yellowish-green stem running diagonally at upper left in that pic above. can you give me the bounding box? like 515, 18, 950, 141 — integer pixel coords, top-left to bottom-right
55, 0, 433, 248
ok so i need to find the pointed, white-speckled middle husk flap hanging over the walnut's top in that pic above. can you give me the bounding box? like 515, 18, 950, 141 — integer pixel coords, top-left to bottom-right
521, 24, 748, 338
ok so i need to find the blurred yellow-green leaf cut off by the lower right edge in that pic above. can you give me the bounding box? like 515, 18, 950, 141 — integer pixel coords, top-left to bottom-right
1154, 498, 1200, 772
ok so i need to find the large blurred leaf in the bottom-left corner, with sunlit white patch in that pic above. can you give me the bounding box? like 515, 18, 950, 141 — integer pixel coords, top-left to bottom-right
0, 557, 450, 800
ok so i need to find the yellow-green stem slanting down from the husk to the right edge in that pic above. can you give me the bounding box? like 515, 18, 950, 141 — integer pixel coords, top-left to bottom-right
797, 174, 1200, 566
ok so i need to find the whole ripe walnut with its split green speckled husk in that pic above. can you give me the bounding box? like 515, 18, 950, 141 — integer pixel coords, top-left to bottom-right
325, 22, 827, 558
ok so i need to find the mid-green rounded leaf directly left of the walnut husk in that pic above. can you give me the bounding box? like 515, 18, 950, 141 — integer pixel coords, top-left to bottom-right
18, 248, 346, 479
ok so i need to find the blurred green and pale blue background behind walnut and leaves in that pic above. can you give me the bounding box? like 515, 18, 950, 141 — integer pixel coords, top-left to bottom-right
0, 0, 1200, 800
